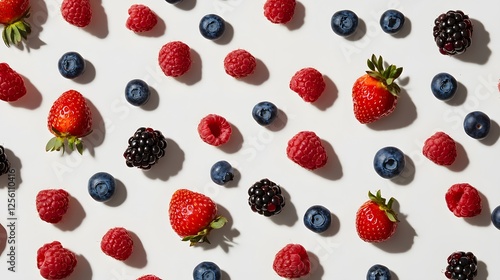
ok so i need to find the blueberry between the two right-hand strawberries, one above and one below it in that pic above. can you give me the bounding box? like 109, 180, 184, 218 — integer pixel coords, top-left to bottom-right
373, 146, 405, 179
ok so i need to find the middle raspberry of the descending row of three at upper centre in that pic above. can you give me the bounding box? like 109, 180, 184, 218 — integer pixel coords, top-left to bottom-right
224, 49, 257, 78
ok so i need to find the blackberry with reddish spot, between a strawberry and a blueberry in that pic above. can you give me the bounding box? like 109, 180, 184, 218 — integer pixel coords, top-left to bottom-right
248, 179, 285, 217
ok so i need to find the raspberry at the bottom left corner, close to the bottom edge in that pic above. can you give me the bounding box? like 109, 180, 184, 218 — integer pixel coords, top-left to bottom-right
36, 241, 77, 279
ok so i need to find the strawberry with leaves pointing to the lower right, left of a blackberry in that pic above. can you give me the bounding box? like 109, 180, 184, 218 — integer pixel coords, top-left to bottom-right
168, 189, 227, 246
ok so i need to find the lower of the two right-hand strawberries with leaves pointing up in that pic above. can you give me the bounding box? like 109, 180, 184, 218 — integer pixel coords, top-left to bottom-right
356, 190, 399, 242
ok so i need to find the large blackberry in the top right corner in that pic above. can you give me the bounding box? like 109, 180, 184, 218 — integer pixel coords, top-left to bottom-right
433, 10, 473, 55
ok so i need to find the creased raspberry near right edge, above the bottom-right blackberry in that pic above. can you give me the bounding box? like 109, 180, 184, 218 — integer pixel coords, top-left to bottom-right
445, 183, 482, 217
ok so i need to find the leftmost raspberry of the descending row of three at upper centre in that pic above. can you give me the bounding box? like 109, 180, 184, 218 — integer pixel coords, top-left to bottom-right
158, 41, 191, 77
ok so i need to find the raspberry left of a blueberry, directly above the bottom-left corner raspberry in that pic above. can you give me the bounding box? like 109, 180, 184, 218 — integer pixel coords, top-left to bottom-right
36, 189, 70, 224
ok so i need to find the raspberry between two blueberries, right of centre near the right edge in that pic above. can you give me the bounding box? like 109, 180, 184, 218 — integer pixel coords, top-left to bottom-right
422, 131, 457, 165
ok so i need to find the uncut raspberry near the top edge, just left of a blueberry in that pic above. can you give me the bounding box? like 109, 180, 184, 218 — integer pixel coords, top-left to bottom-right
125, 4, 158, 33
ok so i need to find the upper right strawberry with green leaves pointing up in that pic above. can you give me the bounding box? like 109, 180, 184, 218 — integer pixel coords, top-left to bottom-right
352, 55, 403, 124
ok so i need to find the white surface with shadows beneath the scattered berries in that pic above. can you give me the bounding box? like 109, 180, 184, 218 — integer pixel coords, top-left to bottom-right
0, 0, 500, 280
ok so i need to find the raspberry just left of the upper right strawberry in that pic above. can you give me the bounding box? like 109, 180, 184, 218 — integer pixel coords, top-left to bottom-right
290, 67, 326, 102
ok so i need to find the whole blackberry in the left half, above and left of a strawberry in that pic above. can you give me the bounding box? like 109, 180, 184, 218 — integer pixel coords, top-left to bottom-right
123, 127, 167, 170
